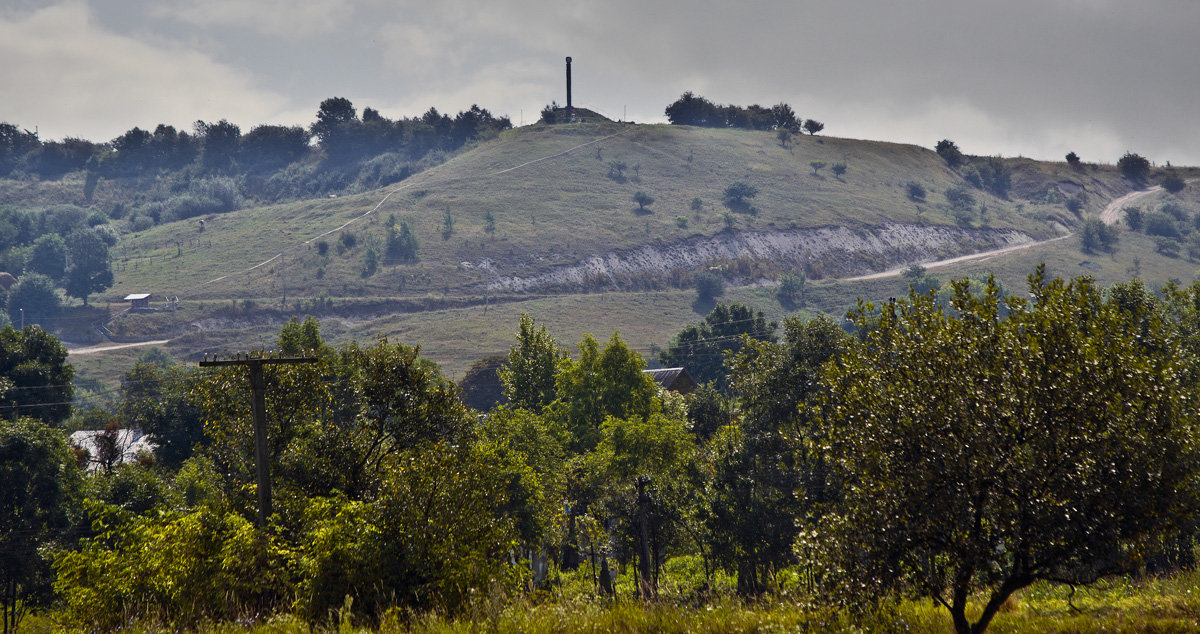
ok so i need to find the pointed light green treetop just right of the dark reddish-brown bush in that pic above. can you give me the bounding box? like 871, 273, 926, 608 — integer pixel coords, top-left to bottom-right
498, 312, 566, 412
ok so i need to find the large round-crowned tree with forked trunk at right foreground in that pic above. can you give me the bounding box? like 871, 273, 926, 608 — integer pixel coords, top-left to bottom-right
811, 267, 1200, 633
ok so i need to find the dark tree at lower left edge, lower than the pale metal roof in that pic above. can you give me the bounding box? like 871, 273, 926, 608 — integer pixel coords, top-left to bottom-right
0, 418, 79, 634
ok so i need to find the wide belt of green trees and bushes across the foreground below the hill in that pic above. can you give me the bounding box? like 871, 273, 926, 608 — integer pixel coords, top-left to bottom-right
7, 268, 1200, 632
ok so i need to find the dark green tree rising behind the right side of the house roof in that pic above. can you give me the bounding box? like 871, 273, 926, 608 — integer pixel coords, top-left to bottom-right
659, 303, 776, 391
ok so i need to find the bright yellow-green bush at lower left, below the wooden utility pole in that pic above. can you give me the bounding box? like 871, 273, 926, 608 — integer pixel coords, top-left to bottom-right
54, 503, 289, 630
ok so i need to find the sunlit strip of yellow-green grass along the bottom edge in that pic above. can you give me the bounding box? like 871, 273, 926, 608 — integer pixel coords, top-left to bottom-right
22, 572, 1200, 634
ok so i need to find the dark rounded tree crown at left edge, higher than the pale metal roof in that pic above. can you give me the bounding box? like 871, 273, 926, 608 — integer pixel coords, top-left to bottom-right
0, 325, 74, 425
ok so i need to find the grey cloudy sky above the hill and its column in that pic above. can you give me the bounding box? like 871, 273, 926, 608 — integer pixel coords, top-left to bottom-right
0, 0, 1200, 166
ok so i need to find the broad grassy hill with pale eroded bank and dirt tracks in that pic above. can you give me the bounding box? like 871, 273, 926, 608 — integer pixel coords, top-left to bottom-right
0, 120, 1196, 389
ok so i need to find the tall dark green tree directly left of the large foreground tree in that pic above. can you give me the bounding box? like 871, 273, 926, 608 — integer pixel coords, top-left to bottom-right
708, 318, 848, 594
